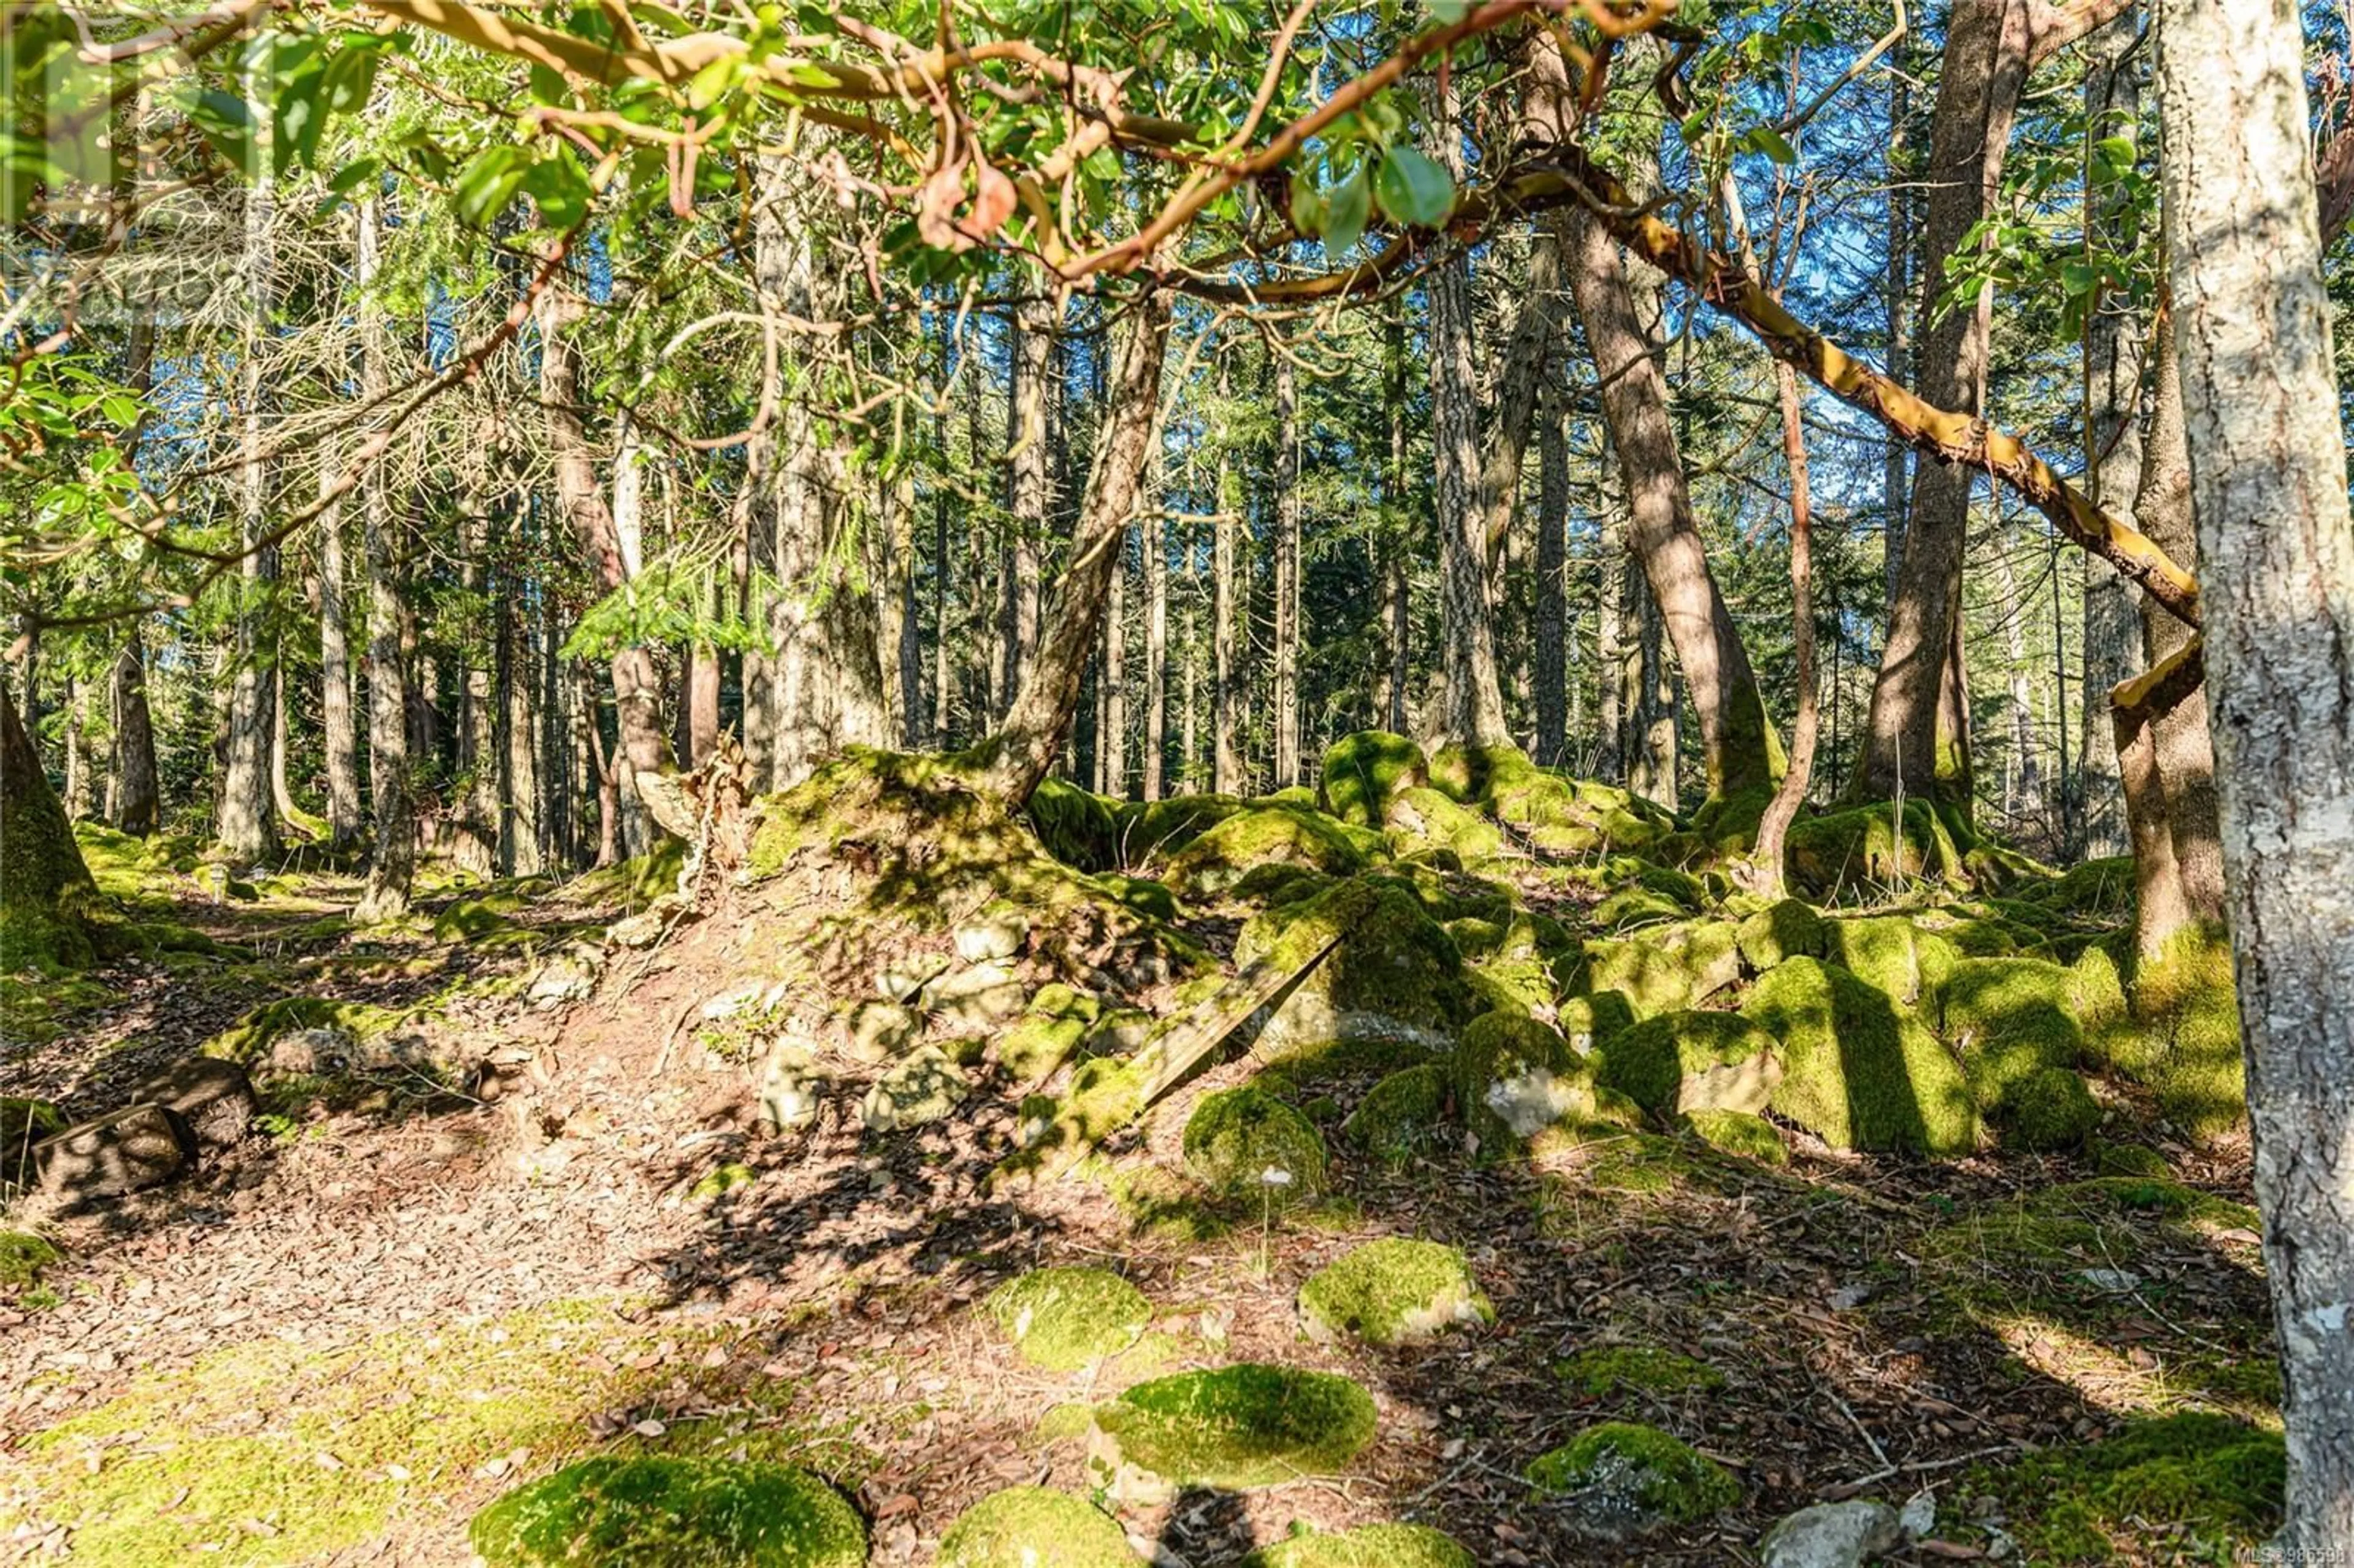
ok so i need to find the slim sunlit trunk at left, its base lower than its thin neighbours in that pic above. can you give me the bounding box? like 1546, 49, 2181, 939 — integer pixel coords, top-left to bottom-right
351, 200, 417, 925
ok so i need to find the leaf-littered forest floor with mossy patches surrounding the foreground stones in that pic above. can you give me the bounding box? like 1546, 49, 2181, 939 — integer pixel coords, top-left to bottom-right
0, 782, 2276, 1568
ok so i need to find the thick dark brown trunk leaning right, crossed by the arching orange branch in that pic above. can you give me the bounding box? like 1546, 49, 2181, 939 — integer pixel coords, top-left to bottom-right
1853, 0, 2034, 812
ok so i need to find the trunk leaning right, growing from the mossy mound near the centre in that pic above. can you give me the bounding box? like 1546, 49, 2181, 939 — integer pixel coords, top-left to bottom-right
975, 292, 1170, 803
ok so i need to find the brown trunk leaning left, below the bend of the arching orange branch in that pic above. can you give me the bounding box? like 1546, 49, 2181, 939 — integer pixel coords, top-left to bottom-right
1570, 212, 1775, 796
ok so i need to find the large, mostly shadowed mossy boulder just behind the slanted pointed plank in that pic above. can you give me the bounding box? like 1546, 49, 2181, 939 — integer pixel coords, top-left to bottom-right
1233, 876, 1471, 1062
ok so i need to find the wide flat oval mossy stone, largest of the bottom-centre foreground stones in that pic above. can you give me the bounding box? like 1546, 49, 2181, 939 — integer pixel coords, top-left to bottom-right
1092, 1361, 1377, 1490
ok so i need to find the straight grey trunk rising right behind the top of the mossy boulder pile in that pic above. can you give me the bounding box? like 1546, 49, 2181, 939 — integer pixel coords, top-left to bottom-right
1424, 82, 1511, 747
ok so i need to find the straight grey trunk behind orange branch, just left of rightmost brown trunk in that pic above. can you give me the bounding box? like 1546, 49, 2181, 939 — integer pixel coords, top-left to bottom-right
2076, 14, 2147, 854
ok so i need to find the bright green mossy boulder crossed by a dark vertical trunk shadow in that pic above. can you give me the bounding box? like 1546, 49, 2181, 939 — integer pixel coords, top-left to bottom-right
1742, 958, 1979, 1156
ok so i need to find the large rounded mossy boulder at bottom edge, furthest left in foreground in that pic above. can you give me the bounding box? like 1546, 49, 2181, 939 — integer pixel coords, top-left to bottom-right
466, 1457, 866, 1568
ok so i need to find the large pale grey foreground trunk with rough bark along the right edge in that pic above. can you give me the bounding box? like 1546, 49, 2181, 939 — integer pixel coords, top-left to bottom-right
2158, 0, 2354, 1535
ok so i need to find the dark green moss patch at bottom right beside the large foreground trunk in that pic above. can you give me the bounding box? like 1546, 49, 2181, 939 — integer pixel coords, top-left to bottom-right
1965, 1413, 2288, 1563
